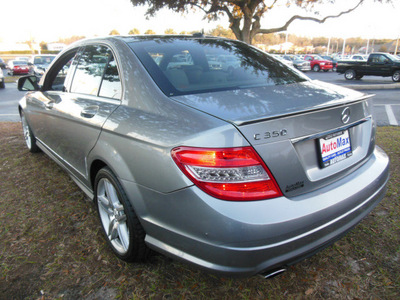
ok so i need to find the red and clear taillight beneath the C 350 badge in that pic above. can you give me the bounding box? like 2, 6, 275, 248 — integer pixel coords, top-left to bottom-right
171, 147, 282, 201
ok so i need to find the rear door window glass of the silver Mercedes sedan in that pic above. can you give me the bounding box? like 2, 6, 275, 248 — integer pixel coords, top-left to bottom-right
71, 45, 121, 99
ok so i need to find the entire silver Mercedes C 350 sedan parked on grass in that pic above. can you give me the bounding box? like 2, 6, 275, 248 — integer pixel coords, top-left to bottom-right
18, 35, 389, 276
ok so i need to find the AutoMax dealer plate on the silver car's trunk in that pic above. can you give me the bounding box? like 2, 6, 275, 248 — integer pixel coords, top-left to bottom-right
319, 130, 353, 168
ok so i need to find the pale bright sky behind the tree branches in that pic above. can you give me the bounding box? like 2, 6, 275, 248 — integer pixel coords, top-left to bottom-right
0, 0, 400, 44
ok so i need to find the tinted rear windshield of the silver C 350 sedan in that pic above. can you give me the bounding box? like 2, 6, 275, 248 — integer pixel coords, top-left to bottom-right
129, 38, 307, 96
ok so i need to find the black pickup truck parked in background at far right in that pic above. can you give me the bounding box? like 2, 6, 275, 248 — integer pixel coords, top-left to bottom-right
337, 52, 400, 82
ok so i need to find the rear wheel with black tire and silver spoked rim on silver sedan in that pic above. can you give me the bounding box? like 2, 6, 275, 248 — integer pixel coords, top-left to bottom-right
94, 167, 150, 262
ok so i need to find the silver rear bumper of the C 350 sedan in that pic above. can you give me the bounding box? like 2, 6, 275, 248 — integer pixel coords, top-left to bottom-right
123, 148, 389, 276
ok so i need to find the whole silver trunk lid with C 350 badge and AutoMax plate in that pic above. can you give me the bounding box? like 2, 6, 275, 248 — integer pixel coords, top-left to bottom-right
174, 82, 375, 197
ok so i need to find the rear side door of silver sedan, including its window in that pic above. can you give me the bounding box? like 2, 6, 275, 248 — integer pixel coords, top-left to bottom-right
43, 45, 122, 181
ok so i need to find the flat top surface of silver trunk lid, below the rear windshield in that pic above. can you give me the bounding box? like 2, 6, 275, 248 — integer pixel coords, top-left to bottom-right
172, 80, 365, 125
